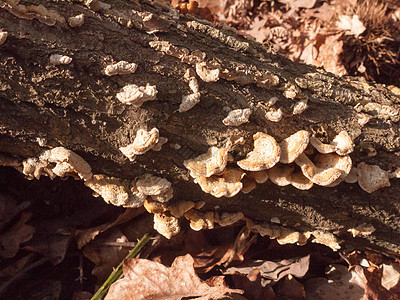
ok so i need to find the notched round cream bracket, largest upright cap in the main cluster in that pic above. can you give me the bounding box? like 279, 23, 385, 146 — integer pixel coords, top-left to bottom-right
237, 132, 281, 171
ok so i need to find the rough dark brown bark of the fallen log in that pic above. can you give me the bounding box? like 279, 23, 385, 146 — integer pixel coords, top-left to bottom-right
0, 1, 400, 254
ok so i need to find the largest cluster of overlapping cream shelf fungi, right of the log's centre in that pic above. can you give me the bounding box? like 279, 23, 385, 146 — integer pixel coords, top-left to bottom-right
184, 130, 394, 198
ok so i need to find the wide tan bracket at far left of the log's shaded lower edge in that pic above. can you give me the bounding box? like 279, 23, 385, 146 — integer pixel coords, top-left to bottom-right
22, 147, 92, 180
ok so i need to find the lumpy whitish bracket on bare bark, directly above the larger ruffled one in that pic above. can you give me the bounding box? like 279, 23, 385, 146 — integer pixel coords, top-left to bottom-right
116, 84, 157, 107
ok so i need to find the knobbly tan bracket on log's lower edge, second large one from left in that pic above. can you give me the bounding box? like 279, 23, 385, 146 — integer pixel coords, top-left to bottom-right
85, 174, 146, 207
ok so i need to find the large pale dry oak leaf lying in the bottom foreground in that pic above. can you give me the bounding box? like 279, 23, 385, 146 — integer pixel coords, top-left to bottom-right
105, 254, 242, 300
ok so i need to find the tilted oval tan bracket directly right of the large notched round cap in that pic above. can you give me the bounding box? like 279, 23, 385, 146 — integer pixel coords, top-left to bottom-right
279, 130, 310, 164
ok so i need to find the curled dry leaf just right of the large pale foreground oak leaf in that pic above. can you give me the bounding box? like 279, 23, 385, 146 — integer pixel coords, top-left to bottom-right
224, 255, 310, 283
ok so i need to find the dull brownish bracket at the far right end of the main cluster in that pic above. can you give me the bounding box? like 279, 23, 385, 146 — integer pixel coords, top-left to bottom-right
357, 162, 390, 193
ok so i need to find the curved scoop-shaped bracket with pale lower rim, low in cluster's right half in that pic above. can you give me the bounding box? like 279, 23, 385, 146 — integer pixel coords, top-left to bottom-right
295, 153, 343, 186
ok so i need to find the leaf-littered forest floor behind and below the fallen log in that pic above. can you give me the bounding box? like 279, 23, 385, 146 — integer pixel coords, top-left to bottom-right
0, 0, 400, 300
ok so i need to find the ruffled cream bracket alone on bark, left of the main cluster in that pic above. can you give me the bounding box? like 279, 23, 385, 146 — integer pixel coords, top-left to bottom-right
119, 127, 159, 161
